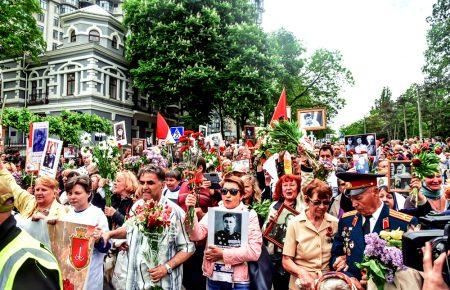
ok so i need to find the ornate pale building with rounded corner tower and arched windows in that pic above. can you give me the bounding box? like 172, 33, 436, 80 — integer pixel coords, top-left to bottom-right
0, 0, 153, 144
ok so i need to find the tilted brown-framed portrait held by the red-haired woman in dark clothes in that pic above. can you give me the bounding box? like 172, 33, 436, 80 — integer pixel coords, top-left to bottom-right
263, 203, 299, 249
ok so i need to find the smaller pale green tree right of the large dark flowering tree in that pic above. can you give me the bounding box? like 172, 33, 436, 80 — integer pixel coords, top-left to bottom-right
269, 29, 354, 120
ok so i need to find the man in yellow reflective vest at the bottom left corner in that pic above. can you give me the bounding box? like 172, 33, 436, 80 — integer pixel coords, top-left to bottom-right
0, 169, 63, 290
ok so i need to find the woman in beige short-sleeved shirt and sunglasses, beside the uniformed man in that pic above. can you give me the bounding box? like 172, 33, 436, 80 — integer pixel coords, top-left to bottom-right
283, 179, 338, 289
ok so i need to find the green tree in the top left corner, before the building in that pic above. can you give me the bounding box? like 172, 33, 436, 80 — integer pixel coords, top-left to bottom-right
0, 0, 45, 60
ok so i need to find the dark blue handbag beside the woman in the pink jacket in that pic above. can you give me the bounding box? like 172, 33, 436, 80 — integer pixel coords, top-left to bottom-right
247, 244, 273, 290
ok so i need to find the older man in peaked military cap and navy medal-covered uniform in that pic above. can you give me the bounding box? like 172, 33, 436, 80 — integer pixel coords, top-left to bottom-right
330, 172, 418, 288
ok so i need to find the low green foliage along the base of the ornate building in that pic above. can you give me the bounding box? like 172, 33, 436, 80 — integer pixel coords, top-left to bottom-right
3, 108, 112, 145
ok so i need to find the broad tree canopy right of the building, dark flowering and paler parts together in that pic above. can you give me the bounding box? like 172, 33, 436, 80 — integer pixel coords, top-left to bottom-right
124, 0, 353, 128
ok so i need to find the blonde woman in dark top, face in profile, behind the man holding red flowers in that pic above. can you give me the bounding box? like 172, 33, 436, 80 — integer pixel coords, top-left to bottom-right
105, 170, 139, 228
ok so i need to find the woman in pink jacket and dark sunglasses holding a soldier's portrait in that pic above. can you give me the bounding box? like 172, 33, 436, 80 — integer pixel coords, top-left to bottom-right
186, 176, 262, 290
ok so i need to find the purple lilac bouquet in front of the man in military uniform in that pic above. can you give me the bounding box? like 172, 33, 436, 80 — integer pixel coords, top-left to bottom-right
356, 233, 405, 290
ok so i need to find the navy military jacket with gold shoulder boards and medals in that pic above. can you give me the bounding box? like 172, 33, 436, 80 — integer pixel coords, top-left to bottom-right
330, 205, 418, 280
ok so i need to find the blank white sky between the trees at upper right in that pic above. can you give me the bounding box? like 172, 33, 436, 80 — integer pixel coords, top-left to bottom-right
262, 0, 435, 130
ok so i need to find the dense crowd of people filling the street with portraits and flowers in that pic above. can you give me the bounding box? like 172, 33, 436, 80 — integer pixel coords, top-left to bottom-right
0, 132, 450, 290
